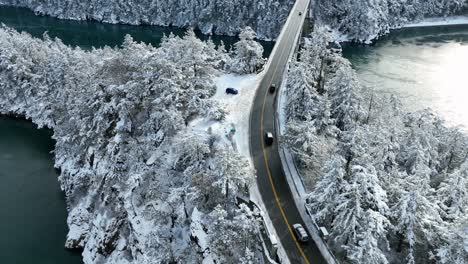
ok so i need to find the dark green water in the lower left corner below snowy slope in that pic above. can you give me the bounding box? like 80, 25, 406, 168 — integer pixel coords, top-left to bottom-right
0, 117, 82, 264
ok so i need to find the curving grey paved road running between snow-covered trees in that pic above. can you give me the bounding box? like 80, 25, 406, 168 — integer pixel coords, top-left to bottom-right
250, 0, 326, 264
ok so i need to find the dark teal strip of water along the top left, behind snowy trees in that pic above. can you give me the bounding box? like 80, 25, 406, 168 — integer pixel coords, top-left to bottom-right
0, 7, 274, 57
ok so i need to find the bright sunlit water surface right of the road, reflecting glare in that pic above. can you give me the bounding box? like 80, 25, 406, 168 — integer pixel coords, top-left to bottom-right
343, 25, 468, 131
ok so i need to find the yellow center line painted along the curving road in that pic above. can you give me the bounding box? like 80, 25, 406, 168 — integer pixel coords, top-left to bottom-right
260, 4, 310, 264
